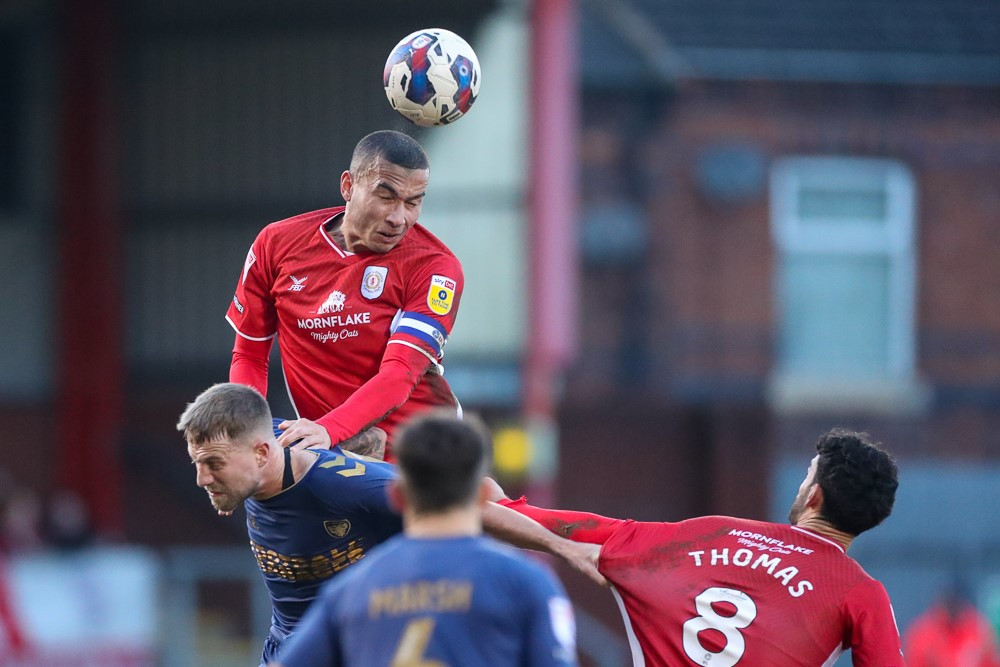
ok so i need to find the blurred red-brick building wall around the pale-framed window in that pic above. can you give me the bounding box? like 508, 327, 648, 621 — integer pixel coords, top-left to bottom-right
568, 83, 1000, 458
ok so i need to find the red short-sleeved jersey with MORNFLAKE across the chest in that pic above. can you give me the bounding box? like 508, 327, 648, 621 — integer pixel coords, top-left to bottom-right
226, 206, 464, 435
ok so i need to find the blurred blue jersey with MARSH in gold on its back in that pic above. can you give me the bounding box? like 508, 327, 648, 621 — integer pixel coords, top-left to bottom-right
278, 535, 576, 667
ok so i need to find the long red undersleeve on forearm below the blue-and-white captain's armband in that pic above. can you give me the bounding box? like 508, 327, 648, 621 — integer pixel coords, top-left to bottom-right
316, 345, 431, 444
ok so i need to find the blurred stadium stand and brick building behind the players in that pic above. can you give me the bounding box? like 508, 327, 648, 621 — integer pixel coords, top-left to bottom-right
0, 0, 1000, 666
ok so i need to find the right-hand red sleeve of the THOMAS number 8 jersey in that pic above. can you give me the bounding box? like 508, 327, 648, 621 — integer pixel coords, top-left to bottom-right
844, 579, 905, 667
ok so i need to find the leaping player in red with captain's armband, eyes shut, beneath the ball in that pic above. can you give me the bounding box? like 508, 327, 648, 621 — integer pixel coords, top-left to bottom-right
226, 131, 464, 460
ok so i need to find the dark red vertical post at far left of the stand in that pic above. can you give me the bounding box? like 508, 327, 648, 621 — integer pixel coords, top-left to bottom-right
54, 0, 125, 534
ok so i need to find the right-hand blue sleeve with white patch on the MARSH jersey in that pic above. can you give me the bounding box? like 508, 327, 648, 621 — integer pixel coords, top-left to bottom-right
524, 567, 577, 667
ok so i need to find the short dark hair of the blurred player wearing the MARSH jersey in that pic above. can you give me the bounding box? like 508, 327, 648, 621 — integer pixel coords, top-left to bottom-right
393, 413, 492, 514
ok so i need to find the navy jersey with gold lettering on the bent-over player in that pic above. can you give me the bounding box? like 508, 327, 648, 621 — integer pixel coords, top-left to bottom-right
243, 419, 402, 639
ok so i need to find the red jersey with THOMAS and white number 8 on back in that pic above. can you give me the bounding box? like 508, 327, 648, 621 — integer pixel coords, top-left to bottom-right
503, 499, 904, 667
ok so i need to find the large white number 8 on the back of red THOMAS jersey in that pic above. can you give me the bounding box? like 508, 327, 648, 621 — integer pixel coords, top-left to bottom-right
683, 587, 757, 667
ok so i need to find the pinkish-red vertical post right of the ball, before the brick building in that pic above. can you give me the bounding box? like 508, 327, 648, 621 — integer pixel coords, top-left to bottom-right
523, 0, 579, 503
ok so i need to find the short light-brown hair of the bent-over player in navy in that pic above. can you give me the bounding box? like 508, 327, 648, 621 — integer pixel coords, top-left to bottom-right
177, 382, 273, 445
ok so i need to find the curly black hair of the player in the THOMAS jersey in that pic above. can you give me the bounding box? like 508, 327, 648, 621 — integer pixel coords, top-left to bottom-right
816, 429, 899, 535
